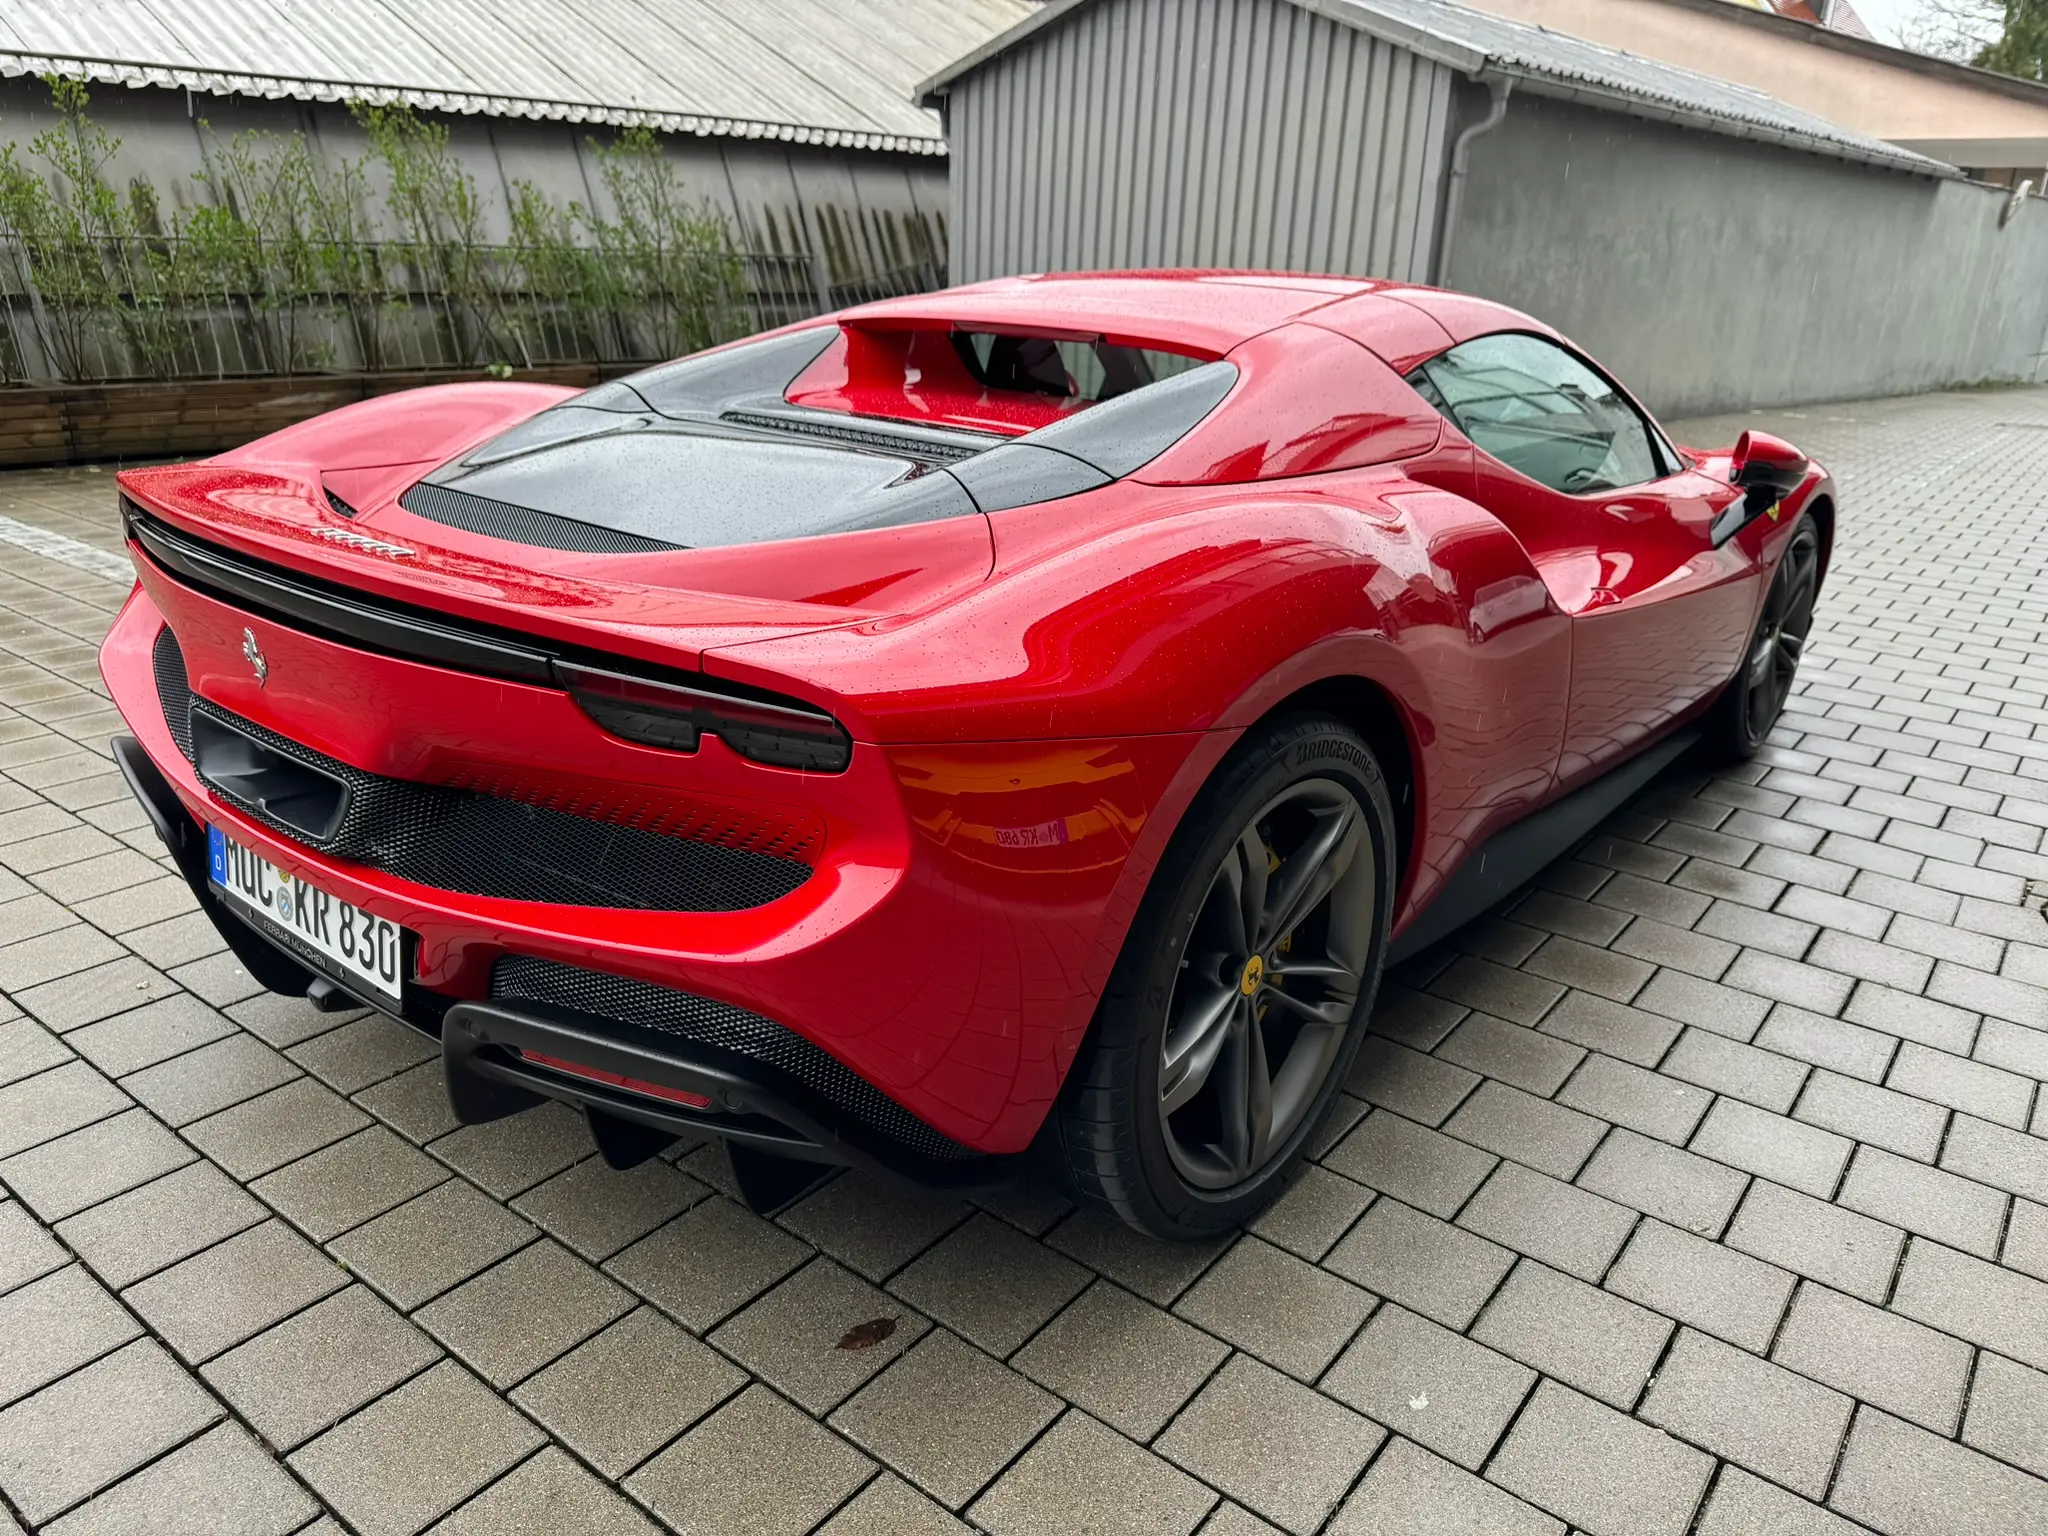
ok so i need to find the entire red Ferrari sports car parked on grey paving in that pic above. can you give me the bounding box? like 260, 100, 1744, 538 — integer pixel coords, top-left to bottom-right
102, 272, 1835, 1237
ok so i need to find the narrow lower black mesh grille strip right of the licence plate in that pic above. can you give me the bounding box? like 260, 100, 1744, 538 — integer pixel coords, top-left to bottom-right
492, 954, 981, 1161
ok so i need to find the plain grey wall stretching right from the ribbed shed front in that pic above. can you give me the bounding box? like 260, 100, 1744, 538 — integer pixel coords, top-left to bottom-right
1446, 92, 2048, 416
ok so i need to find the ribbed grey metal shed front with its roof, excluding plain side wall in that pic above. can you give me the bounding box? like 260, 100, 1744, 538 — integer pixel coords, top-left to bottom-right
920, 0, 1956, 281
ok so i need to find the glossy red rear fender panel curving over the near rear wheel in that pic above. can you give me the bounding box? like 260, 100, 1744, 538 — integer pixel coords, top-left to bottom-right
707, 467, 1571, 958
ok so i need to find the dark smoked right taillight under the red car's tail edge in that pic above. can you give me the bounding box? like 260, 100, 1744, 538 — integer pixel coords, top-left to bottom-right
553, 662, 854, 774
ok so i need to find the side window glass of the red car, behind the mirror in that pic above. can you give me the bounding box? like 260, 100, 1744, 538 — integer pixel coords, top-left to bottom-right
1409, 332, 1671, 496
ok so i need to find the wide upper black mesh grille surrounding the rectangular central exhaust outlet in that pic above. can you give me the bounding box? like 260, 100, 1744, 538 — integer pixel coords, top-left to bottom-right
156, 625, 811, 911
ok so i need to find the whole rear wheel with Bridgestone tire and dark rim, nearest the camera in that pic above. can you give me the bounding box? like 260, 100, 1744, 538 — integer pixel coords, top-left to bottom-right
1051, 715, 1395, 1239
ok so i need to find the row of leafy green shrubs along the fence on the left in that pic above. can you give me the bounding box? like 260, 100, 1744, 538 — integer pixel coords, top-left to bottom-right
0, 76, 770, 379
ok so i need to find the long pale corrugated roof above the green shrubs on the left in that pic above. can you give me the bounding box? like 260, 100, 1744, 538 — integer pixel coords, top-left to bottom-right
0, 0, 1032, 154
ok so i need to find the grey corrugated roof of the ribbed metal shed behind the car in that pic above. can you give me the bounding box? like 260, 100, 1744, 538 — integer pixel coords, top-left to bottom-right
918, 0, 1960, 176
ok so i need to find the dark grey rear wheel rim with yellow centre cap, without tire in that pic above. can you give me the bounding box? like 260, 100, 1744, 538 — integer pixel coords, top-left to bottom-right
1159, 778, 1380, 1190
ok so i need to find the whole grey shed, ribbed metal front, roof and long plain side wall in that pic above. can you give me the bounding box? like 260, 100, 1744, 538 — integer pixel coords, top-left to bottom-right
920, 0, 2048, 414
